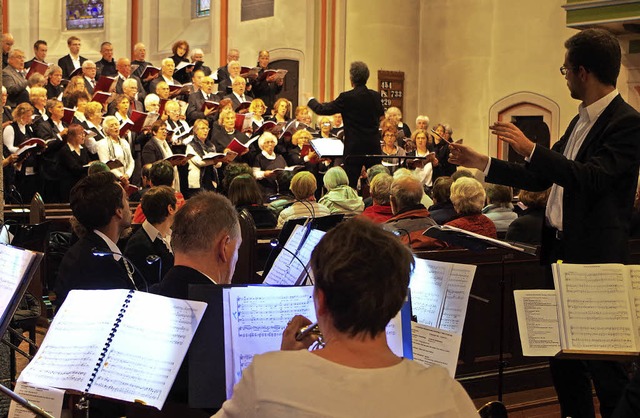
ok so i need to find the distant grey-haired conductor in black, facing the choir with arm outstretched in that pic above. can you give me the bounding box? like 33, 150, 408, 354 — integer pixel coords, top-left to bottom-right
308, 61, 384, 188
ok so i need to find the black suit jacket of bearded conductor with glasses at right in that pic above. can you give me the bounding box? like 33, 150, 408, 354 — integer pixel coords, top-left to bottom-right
486, 96, 640, 264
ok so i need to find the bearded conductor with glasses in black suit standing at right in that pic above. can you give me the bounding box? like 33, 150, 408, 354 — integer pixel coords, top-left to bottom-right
449, 29, 640, 418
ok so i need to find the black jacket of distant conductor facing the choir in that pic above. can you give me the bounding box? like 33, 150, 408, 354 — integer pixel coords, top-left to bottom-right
309, 86, 384, 155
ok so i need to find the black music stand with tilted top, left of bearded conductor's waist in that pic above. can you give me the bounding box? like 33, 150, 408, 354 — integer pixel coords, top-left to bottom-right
422, 225, 537, 402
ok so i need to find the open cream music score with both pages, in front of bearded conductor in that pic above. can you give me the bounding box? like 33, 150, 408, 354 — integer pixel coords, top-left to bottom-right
514, 263, 640, 358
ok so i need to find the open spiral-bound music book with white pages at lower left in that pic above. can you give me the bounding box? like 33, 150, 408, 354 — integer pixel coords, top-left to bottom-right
19, 289, 207, 409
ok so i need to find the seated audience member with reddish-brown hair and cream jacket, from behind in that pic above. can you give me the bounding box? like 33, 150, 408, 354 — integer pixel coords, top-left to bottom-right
278, 171, 331, 228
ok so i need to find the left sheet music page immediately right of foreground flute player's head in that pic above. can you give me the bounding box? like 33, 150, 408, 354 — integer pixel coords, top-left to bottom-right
409, 256, 453, 327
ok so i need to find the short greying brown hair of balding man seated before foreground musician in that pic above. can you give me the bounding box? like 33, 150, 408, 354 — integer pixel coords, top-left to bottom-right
171, 191, 240, 253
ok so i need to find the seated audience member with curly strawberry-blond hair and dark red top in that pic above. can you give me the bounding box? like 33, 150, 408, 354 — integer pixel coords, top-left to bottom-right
445, 177, 497, 238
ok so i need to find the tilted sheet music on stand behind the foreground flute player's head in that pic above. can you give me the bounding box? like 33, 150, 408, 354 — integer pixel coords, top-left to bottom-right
263, 225, 324, 286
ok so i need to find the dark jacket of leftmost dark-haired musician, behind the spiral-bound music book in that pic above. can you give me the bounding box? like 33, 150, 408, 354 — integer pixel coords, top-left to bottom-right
55, 231, 133, 306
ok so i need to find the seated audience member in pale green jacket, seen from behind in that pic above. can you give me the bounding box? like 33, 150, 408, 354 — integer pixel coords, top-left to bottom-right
318, 167, 364, 216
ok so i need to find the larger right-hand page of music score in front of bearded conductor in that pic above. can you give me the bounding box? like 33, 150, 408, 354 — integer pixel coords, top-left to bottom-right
552, 263, 638, 352
